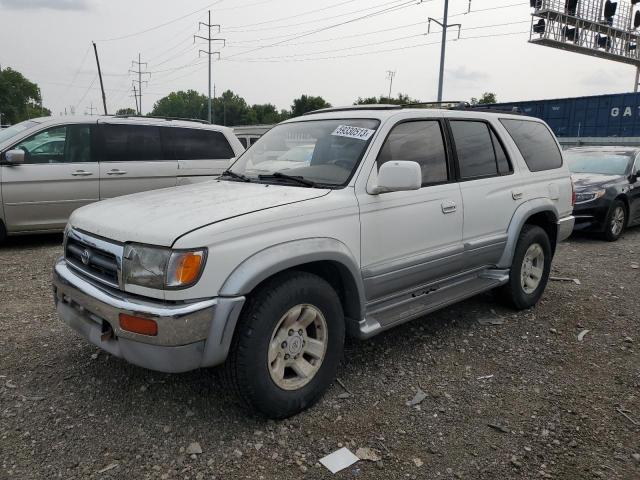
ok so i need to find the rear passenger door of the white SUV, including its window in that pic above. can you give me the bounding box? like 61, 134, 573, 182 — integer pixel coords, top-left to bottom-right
449, 119, 524, 269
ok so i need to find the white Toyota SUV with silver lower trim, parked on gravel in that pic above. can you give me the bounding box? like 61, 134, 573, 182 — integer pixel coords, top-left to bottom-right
54, 106, 574, 418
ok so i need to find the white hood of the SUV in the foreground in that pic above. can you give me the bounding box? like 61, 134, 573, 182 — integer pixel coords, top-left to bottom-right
69, 180, 330, 247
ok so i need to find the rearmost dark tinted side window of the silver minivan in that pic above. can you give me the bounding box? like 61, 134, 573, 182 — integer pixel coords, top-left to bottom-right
162, 128, 235, 160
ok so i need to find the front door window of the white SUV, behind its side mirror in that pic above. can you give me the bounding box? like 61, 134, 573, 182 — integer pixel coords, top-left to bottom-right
378, 120, 449, 186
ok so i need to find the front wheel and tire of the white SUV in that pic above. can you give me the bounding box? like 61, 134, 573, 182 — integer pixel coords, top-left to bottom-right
225, 271, 345, 419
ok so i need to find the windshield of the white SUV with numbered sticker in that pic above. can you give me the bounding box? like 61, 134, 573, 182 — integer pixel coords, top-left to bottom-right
230, 119, 380, 187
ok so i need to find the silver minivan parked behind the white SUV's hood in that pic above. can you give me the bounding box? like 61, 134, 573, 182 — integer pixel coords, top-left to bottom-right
0, 116, 244, 241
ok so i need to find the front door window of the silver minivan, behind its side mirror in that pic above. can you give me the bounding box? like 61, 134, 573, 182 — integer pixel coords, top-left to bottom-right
13, 125, 92, 164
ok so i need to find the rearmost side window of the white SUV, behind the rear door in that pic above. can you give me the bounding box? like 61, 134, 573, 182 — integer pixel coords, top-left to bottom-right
500, 119, 562, 172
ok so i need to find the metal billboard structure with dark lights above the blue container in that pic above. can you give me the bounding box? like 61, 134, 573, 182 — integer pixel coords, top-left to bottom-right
529, 0, 640, 91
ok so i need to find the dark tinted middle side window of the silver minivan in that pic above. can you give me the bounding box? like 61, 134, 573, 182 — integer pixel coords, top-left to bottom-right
101, 124, 164, 162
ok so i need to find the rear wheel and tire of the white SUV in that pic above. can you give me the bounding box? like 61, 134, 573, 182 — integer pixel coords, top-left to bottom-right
499, 225, 552, 310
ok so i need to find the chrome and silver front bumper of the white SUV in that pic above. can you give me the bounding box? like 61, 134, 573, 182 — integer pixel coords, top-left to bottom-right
53, 259, 245, 372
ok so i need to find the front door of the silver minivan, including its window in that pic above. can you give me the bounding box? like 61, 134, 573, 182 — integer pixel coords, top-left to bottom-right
0, 124, 100, 232
